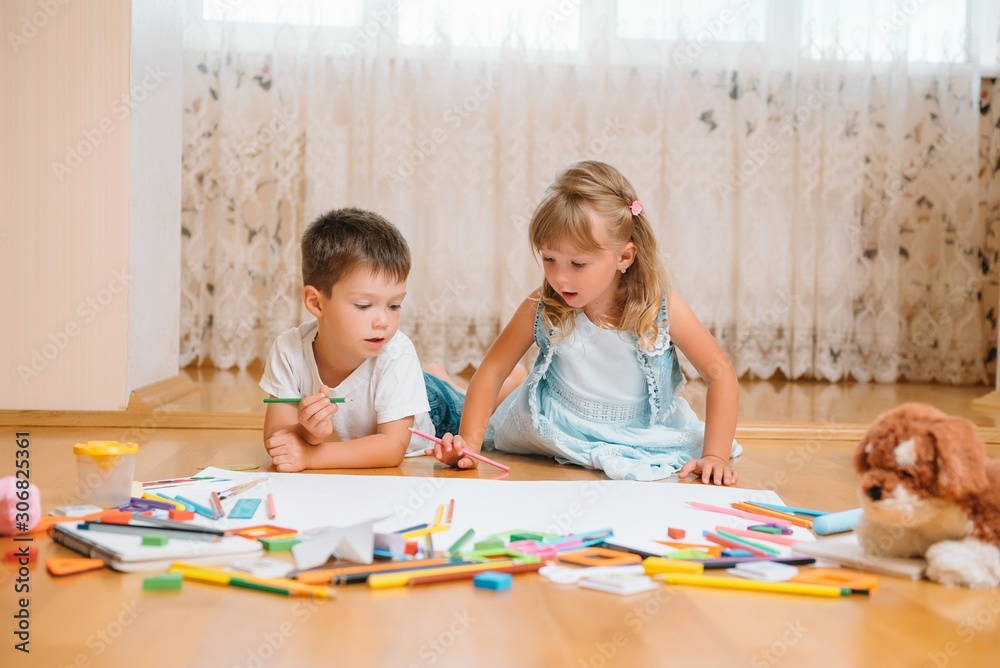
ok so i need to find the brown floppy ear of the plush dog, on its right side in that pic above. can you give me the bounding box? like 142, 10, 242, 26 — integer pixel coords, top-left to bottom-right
927, 416, 987, 499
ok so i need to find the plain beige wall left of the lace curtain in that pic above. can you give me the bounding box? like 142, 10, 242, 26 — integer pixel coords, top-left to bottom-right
0, 0, 180, 410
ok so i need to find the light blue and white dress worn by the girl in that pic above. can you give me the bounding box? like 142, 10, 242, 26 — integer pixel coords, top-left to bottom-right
483, 302, 743, 480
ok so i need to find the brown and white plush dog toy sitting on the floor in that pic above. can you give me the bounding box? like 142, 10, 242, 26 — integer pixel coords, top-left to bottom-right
854, 403, 1000, 588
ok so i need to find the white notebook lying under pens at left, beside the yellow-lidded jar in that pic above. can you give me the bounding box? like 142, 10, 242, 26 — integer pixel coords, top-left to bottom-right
52, 522, 263, 573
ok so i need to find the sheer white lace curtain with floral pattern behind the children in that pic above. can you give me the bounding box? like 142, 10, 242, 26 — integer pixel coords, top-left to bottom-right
181, 0, 1000, 383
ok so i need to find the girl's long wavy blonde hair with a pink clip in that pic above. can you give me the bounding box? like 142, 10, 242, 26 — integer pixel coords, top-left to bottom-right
528, 160, 669, 348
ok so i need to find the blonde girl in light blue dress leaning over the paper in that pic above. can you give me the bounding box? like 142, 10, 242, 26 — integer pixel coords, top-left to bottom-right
427, 161, 742, 485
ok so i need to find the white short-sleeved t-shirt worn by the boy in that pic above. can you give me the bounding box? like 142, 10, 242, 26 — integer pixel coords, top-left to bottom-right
260, 320, 434, 452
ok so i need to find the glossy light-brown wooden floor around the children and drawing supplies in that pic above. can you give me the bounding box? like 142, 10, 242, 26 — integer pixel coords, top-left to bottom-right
0, 370, 1000, 668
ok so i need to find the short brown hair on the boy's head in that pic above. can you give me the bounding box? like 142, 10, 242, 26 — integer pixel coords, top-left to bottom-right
302, 207, 410, 297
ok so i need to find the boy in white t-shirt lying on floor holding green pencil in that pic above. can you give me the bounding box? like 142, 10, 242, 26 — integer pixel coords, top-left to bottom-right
260, 208, 527, 473
